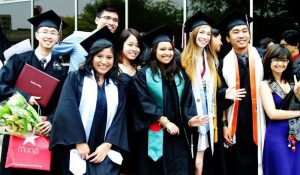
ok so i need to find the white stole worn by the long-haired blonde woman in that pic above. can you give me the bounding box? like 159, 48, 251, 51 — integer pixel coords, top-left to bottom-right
192, 50, 216, 153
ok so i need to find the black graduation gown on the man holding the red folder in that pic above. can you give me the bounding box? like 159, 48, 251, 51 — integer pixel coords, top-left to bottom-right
0, 50, 67, 175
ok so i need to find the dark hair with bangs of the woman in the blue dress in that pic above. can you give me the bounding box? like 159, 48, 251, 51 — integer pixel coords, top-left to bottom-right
263, 44, 292, 82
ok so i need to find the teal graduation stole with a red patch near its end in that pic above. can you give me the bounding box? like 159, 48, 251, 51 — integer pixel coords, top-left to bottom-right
146, 68, 184, 161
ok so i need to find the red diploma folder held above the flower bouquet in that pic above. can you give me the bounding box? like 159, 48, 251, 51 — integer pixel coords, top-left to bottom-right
15, 64, 59, 107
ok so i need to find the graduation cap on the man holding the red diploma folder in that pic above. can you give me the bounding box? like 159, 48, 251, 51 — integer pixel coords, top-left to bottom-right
28, 10, 67, 31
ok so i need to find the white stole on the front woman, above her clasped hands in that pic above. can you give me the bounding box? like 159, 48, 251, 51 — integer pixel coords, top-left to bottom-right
79, 71, 119, 142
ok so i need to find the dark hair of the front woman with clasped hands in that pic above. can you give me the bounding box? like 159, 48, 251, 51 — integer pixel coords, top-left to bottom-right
79, 46, 119, 83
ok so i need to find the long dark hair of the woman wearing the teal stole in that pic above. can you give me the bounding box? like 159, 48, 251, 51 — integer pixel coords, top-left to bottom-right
150, 43, 182, 82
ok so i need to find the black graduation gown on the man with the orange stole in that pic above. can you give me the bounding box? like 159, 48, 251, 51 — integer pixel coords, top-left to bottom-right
221, 55, 258, 175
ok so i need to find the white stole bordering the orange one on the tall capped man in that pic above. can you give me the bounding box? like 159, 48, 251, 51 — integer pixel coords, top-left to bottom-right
222, 45, 266, 175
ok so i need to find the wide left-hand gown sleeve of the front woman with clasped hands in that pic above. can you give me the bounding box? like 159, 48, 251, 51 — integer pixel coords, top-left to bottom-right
50, 71, 86, 149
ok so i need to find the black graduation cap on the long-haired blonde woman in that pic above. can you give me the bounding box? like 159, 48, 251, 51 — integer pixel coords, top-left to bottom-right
184, 11, 214, 33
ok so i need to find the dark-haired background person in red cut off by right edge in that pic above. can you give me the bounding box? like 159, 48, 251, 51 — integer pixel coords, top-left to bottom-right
280, 30, 300, 79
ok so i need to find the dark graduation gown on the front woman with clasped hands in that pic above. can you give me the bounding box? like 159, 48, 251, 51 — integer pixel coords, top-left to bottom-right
50, 71, 128, 175
